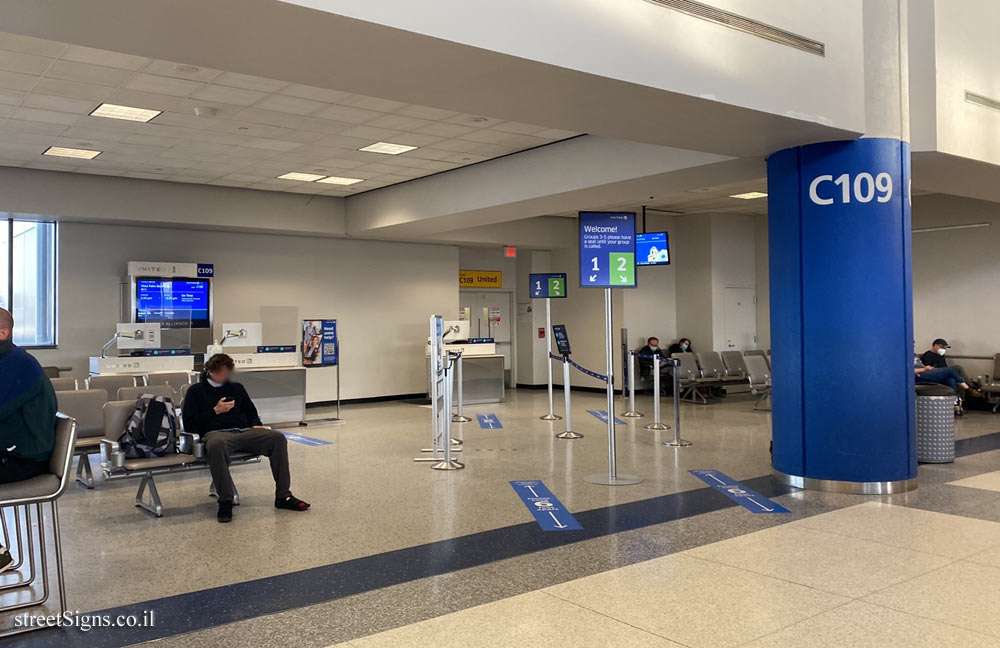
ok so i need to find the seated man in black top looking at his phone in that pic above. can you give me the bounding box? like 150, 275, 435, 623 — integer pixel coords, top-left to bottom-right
183, 353, 309, 522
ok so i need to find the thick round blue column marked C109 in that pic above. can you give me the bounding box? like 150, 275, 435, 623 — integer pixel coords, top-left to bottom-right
767, 138, 917, 491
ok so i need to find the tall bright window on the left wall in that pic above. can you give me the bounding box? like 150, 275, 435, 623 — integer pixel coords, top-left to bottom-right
0, 216, 56, 347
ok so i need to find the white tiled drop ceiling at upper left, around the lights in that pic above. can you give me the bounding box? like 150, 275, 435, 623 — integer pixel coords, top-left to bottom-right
0, 32, 577, 196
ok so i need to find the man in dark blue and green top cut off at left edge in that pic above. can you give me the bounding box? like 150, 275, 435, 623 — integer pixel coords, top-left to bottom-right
0, 308, 57, 572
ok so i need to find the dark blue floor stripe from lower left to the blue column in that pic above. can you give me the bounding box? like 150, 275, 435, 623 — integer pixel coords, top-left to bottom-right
18, 475, 797, 648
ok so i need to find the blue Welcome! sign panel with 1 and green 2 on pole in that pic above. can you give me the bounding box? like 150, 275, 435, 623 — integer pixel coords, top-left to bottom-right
580, 212, 635, 288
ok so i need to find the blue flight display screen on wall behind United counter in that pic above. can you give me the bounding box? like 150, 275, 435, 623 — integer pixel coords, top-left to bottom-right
135, 279, 210, 328
